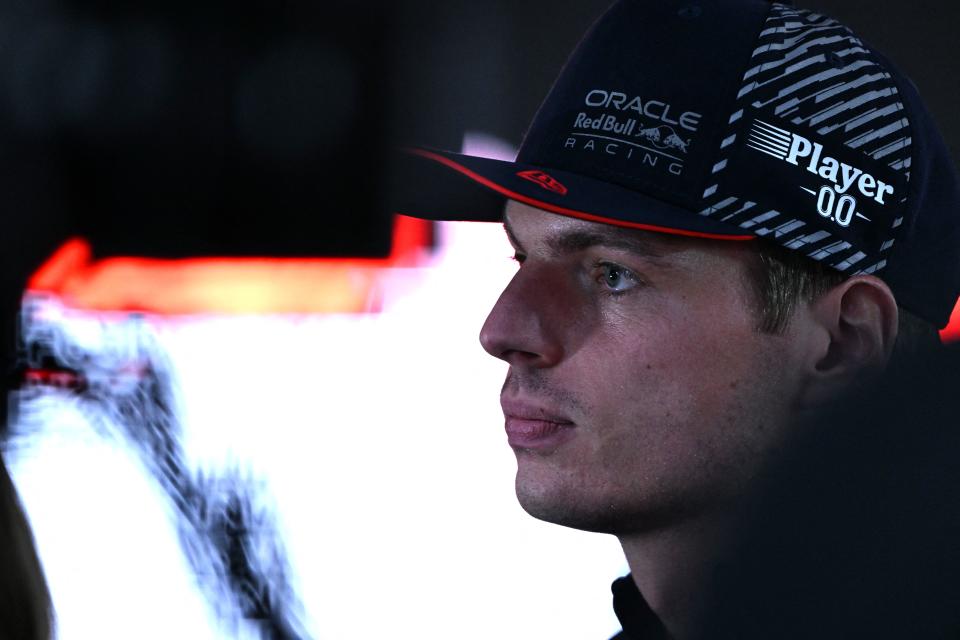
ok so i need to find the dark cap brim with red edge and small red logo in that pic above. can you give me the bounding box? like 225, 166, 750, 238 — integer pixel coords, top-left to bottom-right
394, 148, 756, 240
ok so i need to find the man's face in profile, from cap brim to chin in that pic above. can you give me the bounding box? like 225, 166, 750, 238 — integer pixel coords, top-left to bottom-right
480, 203, 800, 534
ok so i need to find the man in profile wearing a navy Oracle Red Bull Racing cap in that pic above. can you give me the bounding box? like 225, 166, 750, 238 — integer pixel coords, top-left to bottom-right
400, 0, 960, 638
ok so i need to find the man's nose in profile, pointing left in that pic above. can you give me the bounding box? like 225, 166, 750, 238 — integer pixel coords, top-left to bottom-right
480, 265, 570, 368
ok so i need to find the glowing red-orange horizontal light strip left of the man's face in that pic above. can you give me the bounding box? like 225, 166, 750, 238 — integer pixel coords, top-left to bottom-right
27, 215, 430, 315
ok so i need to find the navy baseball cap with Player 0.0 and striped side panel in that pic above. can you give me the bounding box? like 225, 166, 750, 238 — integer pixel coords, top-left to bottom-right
395, 0, 960, 327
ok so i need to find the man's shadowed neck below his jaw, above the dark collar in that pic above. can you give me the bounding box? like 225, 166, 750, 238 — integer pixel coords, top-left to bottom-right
618, 510, 731, 640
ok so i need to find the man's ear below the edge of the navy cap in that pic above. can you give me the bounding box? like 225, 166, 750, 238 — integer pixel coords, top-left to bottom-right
803, 275, 898, 406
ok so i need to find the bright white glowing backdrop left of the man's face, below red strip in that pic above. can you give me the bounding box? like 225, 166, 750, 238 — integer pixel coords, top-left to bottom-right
12, 218, 626, 640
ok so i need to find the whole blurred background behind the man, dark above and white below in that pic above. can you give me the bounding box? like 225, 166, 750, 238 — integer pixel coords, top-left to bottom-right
0, 0, 960, 639
